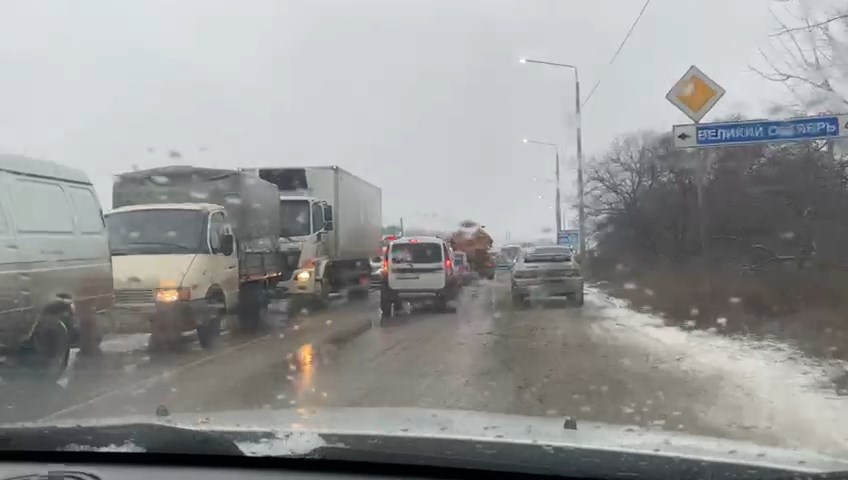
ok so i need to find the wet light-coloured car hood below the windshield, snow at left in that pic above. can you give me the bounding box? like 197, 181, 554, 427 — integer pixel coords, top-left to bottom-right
6, 408, 848, 478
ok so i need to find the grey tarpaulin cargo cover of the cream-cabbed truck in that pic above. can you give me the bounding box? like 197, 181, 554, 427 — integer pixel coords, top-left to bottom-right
112, 166, 285, 278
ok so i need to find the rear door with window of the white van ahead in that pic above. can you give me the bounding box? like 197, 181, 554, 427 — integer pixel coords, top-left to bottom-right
389, 242, 446, 291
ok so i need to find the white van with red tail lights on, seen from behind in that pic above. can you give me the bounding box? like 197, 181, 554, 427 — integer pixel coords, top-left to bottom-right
380, 237, 460, 318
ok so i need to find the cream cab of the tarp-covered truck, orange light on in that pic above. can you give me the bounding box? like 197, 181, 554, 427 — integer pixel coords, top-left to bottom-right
106, 203, 239, 347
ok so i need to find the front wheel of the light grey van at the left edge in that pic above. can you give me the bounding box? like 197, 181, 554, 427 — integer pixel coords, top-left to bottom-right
24, 315, 71, 383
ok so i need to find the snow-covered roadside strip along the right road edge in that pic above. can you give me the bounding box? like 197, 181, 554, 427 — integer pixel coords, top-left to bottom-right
586, 288, 848, 456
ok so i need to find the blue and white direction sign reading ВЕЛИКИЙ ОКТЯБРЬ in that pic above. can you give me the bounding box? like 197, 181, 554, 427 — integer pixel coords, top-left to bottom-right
672, 115, 848, 148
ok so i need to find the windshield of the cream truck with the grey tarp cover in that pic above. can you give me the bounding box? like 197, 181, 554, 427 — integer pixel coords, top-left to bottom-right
106, 209, 206, 255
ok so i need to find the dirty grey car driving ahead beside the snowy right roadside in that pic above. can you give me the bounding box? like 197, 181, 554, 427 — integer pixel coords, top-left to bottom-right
510, 246, 583, 307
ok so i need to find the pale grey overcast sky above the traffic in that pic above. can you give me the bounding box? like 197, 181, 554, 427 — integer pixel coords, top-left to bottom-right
0, 0, 784, 240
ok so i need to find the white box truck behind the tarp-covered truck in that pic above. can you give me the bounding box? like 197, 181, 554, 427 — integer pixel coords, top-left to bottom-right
248, 166, 383, 308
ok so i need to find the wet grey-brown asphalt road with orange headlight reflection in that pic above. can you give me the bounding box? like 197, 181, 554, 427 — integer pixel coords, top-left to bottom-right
0, 280, 781, 444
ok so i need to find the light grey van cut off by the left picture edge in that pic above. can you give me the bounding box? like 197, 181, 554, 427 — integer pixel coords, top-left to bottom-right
0, 155, 112, 381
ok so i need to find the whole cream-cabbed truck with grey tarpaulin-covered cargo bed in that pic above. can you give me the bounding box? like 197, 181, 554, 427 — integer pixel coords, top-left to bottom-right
106, 166, 284, 348
